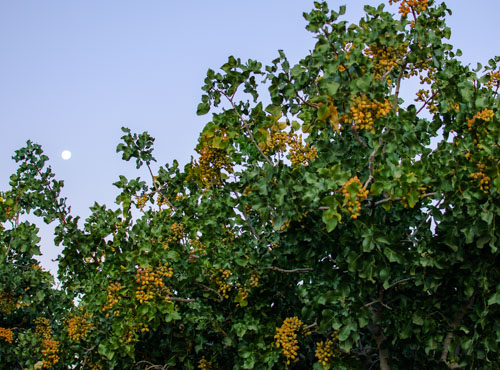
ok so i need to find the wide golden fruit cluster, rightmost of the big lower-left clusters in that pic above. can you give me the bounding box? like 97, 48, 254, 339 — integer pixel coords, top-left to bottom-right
135, 264, 174, 303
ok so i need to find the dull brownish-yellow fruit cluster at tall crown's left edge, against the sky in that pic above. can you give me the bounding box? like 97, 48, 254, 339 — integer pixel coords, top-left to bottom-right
196, 145, 233, 189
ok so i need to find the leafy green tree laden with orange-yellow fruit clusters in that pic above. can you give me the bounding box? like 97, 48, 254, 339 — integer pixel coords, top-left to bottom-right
0, 0, 500, 369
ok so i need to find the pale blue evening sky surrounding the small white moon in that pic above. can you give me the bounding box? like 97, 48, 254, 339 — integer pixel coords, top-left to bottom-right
0, 0, 500, 272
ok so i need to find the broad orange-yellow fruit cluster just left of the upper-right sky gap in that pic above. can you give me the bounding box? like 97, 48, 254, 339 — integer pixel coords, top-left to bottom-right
341, 95, 392, 133
